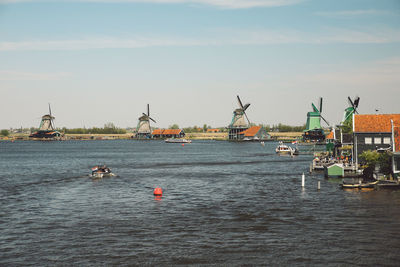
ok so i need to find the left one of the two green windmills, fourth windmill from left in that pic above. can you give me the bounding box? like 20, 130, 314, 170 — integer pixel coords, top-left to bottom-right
303, 97, 329, 142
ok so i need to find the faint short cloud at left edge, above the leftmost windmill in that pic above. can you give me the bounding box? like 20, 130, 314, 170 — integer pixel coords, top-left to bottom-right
0, 70, 71, 81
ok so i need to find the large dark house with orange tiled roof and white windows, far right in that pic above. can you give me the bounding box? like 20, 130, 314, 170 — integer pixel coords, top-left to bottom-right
353, 114, 400, 169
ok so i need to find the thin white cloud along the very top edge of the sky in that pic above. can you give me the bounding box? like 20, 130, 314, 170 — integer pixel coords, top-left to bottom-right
0, 0, 304, 9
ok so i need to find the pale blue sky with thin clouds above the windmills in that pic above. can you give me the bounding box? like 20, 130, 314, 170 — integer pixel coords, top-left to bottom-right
0, 0, 400, 129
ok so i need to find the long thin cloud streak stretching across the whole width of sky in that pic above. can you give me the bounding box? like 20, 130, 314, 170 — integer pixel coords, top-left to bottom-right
0, 28, 400, 51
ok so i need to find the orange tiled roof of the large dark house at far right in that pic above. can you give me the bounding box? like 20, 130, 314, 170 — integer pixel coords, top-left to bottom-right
353, 114, 400, 133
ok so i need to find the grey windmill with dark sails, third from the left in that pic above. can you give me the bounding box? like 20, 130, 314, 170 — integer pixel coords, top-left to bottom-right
228, 96, 250, 140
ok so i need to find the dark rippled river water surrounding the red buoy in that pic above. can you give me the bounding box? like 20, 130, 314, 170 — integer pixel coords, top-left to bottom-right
0, 140, 400, 266
